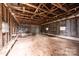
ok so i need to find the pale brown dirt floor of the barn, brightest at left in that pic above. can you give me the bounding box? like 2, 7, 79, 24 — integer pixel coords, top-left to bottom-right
8, 35, 79, 56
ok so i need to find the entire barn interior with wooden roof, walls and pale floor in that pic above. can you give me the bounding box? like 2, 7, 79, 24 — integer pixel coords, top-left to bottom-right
0, 3, 79, 56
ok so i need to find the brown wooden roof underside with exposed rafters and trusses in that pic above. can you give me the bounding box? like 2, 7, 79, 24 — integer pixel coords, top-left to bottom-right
3, 3, 79, 25
